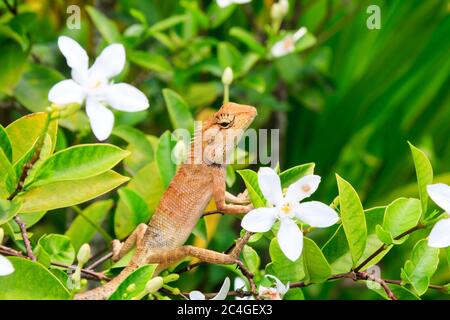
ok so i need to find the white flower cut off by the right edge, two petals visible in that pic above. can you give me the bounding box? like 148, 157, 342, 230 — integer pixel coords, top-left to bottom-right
427, 183, 450, 248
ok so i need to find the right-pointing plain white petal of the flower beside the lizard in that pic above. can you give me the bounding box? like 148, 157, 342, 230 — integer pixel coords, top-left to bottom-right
294, 201, 339, 228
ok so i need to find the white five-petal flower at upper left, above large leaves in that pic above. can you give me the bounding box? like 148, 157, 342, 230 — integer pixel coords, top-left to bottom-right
48, 36, 149, 141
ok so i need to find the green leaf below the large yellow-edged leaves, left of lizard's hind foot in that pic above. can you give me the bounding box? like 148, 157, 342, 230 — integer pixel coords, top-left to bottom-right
65, 199, 114, 252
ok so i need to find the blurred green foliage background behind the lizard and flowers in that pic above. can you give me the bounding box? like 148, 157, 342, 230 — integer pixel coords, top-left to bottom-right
0, 0, 450, 299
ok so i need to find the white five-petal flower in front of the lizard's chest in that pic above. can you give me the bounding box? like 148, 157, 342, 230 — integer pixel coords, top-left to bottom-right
241, 168, 339, 261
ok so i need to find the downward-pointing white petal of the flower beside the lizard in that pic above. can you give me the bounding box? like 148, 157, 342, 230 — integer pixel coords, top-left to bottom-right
277, 218, 303, 261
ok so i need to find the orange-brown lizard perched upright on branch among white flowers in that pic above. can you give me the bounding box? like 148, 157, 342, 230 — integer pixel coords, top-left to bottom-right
74, 102, 257, 300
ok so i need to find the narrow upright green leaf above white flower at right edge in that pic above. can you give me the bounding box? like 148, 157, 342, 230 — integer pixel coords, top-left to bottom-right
408, 142, 433, 215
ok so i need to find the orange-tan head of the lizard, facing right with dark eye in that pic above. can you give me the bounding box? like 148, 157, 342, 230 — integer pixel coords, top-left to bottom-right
202, 102, 257, 165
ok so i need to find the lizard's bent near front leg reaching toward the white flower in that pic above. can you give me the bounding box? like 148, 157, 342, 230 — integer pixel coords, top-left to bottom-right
212, 168, 253, 214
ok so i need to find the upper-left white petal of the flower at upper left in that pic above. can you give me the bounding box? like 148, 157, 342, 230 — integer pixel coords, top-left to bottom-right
58, 36, 89, 84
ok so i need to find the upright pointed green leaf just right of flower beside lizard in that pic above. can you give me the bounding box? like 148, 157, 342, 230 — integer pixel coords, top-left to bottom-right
336, 175, 367, 266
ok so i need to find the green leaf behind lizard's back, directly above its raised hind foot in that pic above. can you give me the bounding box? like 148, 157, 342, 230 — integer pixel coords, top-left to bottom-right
114, 187, 152, 238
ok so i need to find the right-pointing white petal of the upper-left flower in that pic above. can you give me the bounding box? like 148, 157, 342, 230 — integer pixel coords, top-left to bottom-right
106, 83, 149, 112
